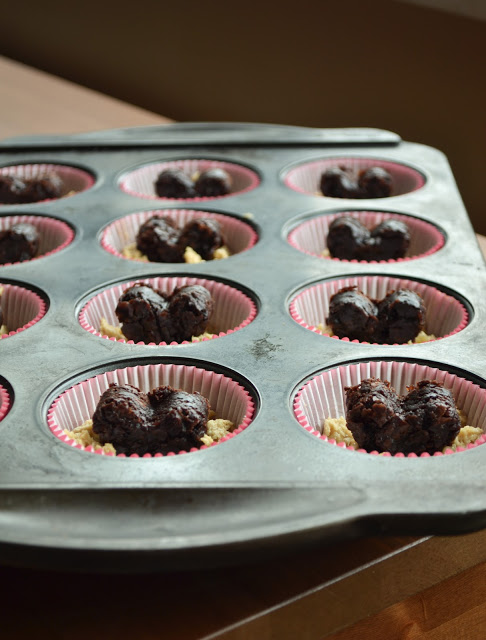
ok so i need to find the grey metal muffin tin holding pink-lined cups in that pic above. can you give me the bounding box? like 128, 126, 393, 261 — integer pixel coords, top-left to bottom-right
0, 123, 486, 570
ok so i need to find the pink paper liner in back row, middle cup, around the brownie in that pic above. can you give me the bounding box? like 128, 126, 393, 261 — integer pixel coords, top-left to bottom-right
119, 159, 260, 202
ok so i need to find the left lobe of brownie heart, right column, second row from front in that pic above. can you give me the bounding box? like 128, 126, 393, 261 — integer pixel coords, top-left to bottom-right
326, 286, 379, 342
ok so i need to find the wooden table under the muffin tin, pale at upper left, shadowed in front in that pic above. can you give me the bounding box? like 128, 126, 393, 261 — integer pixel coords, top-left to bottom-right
0, 58, 486, 640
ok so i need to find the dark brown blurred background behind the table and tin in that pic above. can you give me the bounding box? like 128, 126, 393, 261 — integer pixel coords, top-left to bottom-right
0, 0, 486, 234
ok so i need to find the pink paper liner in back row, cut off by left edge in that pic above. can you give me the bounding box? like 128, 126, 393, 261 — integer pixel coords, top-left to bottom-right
0, 163, 95, 202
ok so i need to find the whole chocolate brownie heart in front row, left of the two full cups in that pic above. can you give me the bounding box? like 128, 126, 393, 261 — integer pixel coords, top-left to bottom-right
93, 384, 209, 456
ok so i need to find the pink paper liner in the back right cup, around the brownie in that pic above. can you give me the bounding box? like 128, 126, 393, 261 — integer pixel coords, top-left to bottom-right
284, 156, 425, 200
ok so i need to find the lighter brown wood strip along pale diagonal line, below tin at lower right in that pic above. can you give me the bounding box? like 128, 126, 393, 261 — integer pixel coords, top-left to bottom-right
207, 531, 486, 640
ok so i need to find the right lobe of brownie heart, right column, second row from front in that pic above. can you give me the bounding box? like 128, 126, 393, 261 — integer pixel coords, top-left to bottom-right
378, 289, 426, 344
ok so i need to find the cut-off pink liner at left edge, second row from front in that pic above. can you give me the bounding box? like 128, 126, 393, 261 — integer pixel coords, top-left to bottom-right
0, 282, 47, 339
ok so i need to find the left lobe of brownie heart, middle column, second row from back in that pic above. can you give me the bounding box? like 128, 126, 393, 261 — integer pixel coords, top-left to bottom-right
137, 216, 184, 262
